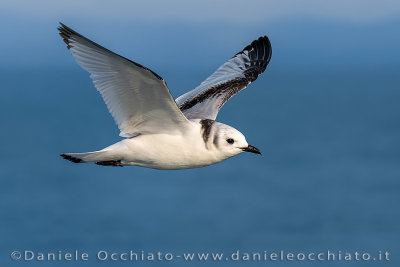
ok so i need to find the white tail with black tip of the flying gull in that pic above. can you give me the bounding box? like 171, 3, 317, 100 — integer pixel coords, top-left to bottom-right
60, 150, 122, 166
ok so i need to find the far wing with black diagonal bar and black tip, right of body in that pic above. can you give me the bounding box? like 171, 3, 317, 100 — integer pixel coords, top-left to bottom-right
176, 36, 272, 120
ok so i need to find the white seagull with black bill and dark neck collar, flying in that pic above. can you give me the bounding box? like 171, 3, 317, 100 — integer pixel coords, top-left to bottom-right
58, 23, 272, 170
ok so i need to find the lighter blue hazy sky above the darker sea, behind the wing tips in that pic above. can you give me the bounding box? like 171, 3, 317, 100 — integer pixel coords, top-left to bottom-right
0, 0, 400, 72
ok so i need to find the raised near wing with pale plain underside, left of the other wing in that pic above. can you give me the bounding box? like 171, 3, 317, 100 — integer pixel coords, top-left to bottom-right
58, 23, 190, 137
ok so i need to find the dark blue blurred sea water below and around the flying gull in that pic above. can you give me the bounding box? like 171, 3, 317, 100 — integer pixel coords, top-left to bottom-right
0, 68, 400, 266
